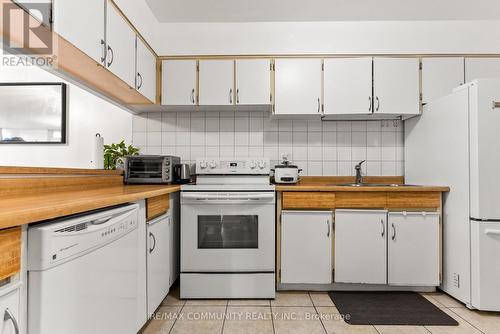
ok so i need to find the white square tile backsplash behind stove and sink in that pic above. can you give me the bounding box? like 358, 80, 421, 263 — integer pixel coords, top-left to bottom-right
133, 111, 404, 176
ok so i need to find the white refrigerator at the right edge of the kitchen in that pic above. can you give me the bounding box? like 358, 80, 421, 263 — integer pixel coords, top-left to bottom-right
405, 79, 500, 311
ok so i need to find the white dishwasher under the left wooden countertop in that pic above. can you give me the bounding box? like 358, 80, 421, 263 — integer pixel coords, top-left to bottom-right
28, 204, 143, 334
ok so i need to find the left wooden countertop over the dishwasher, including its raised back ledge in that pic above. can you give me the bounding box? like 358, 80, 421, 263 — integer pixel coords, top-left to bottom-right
0, 166, 180, 229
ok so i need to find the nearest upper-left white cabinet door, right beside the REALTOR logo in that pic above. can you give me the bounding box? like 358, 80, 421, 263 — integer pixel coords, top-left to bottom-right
53, 0, 106, 65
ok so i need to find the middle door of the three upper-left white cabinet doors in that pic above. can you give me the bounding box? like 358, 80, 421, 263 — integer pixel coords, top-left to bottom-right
106, 1, 136, 87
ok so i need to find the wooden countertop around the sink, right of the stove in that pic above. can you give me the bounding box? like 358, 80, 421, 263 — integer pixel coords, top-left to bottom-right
276, 176, 450, 192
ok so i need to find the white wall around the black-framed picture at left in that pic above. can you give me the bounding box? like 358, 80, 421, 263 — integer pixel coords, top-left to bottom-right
0, 66, 132, 168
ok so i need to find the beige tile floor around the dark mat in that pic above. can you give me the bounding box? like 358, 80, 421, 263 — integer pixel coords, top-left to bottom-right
142, 289, 500, 334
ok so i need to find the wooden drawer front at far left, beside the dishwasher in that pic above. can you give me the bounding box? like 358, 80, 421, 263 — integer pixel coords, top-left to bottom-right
0, 227, 21, 280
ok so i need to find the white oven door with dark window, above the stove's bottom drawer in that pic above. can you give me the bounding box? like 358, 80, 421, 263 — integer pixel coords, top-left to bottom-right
181, 191, 275, 273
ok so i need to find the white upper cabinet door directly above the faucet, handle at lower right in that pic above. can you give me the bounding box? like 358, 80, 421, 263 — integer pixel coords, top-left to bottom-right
323, 58, 373, 114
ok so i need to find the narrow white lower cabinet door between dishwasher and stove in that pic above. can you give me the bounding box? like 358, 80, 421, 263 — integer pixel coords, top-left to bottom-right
147, 216, 171, 314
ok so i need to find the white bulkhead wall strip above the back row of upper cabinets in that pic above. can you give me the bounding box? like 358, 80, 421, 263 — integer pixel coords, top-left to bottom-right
155, 21, 500, 55
